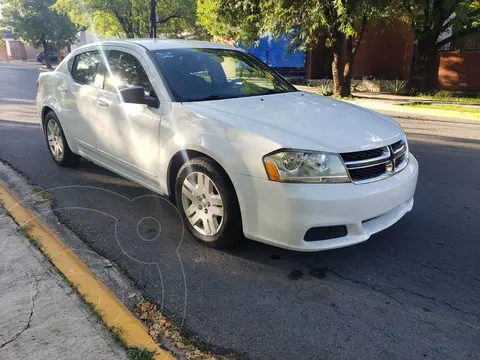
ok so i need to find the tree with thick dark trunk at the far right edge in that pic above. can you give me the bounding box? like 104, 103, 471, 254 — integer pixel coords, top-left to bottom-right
402, 0, 480, 92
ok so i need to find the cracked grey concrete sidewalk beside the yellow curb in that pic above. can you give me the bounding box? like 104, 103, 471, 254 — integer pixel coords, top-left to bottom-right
0, 206, 127, 360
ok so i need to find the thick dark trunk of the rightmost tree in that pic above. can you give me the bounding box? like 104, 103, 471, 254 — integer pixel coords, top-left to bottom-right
413, 37, 438, 93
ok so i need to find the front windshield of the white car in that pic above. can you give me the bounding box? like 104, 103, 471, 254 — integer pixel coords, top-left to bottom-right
152, 49, 297, 102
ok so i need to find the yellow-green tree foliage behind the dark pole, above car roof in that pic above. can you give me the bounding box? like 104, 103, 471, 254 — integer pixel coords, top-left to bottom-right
55, 0, 195, 38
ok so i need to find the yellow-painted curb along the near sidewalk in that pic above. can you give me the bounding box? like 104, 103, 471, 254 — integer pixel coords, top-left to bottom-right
0, 182, 175, 360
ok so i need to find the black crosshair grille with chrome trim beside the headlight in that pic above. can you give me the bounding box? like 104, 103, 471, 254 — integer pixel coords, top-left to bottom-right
341, 139, 408, 184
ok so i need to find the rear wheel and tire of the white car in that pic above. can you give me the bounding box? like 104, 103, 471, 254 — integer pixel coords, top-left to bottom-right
44, 111, 80, 167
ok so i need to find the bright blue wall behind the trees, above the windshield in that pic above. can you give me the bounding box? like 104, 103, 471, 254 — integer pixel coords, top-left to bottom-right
239, 36, 305, 68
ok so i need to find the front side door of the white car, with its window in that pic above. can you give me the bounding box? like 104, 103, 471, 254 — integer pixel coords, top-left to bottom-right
93, 49, 162, 187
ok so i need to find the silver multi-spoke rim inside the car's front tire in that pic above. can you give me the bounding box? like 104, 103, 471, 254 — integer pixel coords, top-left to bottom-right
182, 172, 224, 236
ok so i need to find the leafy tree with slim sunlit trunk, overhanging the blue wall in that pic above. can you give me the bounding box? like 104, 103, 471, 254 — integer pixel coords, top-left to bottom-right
197, 0, 389, 97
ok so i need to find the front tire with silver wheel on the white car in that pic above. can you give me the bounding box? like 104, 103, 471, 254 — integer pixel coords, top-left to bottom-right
175, 157, 243, 248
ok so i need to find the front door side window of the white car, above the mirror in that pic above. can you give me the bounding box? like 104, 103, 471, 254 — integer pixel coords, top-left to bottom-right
104, 51, 153, 94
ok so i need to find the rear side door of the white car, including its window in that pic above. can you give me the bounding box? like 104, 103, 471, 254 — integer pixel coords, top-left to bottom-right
56, 50, 101, 155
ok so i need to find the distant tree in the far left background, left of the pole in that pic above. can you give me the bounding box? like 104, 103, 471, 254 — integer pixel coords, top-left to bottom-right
2, 0, 77, 68
